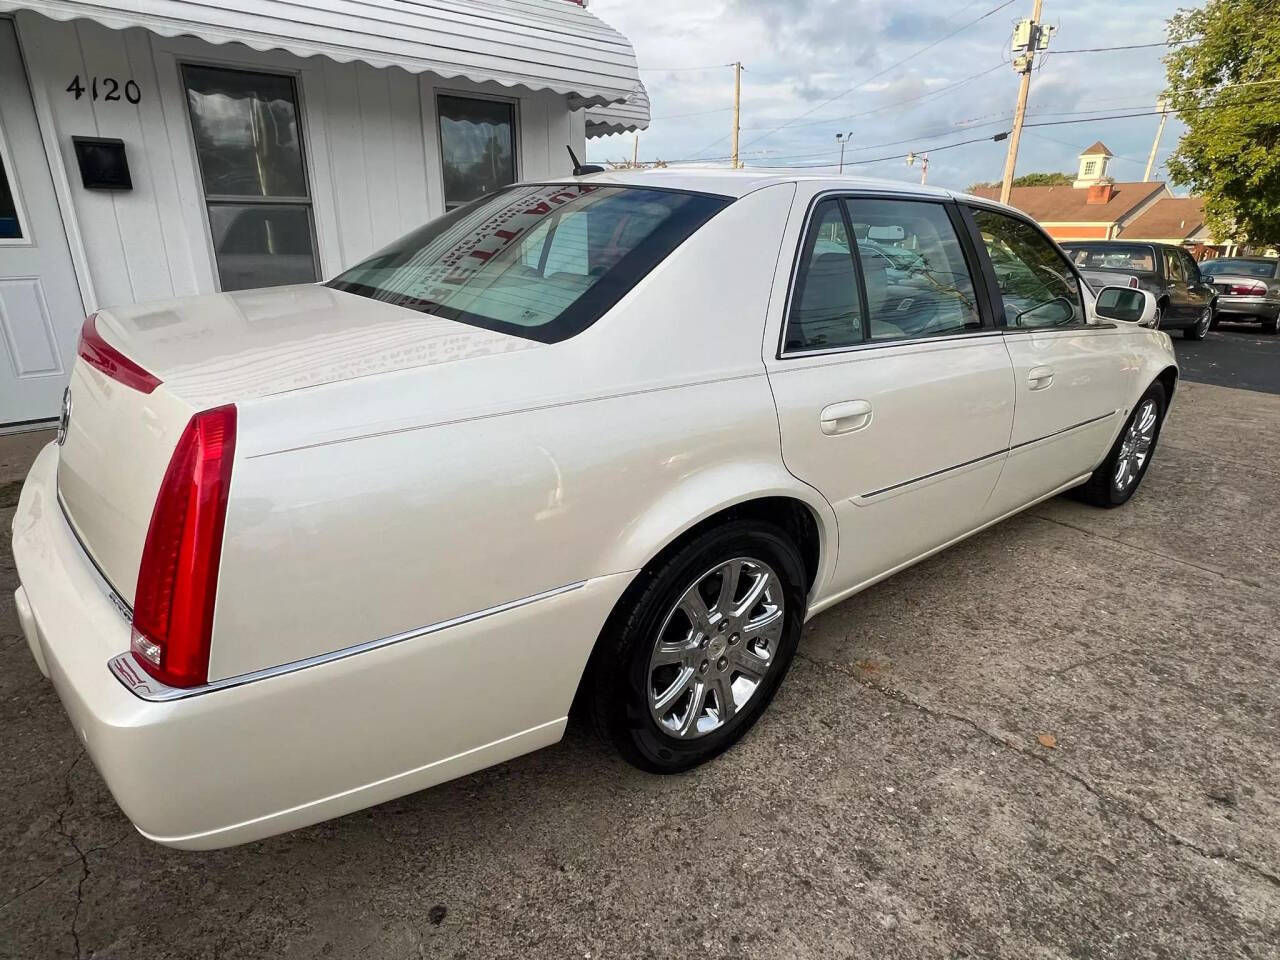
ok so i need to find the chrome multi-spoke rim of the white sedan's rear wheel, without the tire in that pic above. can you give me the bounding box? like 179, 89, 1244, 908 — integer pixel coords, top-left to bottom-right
646, 557, 785, 740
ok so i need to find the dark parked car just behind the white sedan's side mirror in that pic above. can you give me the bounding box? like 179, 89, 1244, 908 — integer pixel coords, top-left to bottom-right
1062, 241, 1217, 340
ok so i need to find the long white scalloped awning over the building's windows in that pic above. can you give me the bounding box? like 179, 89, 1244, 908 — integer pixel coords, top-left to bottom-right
0, 0, 640, 109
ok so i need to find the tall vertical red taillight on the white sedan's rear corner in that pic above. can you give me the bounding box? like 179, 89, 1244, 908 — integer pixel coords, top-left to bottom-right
132, 404, 236, 686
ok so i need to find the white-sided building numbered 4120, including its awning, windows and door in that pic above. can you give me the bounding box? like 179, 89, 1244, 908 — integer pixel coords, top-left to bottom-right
0, 0, 648, 425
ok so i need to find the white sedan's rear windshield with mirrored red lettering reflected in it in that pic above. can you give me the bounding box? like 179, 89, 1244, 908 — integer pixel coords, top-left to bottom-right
329, 184, 730, 343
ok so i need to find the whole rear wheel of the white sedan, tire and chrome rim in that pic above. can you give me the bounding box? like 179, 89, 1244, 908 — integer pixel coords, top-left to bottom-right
584, 520, 805, 773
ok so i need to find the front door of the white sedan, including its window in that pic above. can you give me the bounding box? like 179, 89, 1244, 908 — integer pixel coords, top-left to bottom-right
968, 207, 1138, 515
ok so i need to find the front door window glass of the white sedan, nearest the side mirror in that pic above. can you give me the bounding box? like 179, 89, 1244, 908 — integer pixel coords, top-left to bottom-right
973, 210, 1085, 328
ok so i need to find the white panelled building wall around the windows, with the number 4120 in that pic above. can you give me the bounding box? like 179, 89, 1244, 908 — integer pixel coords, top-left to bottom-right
15, 13, 585, 310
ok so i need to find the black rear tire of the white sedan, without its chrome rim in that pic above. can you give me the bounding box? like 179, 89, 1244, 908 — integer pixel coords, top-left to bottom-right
581, 520, 805, 773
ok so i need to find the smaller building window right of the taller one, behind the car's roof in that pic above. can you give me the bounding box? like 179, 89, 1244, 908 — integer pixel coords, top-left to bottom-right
435, 95, 516, 210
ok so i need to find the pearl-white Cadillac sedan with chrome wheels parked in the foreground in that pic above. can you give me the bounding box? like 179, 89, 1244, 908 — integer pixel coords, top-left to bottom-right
13, 170, 1176, 849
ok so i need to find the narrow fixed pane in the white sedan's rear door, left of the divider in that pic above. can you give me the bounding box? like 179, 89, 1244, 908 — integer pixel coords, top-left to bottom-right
785, 200, 867, 351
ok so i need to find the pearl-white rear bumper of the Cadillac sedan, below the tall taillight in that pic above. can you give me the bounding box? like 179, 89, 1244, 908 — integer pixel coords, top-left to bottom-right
13, 444, 628, 849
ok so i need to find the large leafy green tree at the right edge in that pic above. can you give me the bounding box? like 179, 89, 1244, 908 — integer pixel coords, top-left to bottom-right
1165, 0, 1280, 244
